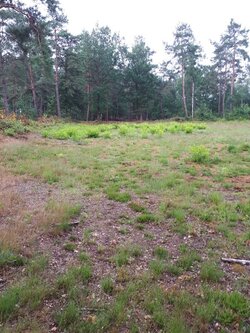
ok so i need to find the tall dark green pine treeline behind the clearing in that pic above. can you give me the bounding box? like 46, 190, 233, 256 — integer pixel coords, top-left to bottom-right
0, 0, 250, 121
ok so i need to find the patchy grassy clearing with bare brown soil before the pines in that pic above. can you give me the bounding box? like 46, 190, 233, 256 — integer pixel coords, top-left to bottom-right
0, 122, 250, 333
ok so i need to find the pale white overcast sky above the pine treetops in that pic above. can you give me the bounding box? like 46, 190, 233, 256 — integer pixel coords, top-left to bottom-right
60, 0, 250, 62
